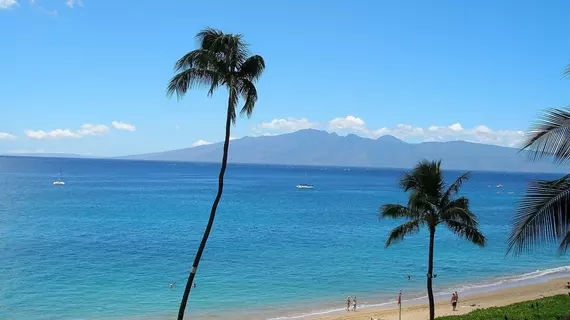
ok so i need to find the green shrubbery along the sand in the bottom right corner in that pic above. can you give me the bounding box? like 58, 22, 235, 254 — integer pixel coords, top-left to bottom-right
437, 295, 570, 320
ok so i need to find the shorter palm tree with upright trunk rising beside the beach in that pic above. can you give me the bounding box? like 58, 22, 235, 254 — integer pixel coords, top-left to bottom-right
380, 160, 487, 320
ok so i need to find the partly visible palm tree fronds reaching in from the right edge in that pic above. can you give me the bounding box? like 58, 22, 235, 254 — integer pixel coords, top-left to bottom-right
507, 107, 570, 254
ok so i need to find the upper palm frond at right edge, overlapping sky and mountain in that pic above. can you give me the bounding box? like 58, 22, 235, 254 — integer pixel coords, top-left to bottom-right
521, 107, 570, 163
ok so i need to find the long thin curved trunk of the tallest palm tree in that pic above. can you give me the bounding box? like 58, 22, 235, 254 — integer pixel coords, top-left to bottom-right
178, 94, 232, 320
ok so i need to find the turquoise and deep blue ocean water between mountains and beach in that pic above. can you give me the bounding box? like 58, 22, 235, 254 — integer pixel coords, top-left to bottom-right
0, 157, 570, 319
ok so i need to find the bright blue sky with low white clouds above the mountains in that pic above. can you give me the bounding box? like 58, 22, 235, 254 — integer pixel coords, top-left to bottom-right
0, 0, 570, 156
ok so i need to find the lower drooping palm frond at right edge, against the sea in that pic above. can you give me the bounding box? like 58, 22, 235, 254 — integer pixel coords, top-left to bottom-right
507, 175, 570, 254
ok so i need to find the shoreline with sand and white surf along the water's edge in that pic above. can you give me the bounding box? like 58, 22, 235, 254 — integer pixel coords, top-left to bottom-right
172, 266, 570, 320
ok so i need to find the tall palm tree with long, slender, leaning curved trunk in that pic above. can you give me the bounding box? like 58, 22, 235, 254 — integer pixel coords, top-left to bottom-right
167, 28, 265, 320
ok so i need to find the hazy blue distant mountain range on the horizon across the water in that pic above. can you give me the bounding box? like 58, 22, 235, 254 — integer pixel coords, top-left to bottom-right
122, 129, 569, 172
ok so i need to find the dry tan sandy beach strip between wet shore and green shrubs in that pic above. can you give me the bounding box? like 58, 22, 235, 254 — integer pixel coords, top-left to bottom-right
311, 278, 570, 320
